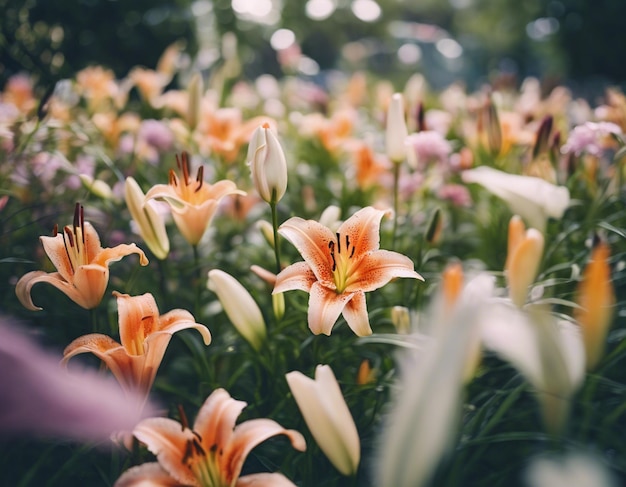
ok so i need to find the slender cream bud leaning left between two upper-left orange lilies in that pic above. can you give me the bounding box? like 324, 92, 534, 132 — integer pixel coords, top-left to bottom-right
124, 177, 170, 260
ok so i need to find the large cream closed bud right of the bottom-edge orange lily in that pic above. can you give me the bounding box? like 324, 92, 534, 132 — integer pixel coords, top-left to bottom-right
285, 365, 361, 475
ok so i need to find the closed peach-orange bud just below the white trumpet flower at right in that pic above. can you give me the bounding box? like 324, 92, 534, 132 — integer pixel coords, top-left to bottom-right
504, 215, 544, 308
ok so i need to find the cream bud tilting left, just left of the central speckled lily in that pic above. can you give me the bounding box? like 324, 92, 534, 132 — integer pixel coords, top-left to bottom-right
207, 269, 267, 350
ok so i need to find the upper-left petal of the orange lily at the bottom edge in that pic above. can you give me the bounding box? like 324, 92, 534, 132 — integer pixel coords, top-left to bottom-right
133, 418, 199, 485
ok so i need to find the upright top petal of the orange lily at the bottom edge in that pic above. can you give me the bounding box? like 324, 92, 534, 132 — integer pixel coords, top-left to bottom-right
194, 389, 246, 458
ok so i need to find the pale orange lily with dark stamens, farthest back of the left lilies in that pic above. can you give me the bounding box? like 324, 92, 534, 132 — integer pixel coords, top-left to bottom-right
146, 152, 246, 245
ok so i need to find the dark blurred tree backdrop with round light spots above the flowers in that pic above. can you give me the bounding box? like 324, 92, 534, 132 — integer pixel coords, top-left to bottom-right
0, 0, 626, 99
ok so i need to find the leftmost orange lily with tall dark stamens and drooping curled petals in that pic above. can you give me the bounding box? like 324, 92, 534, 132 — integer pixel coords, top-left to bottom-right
15, 203, 148, 311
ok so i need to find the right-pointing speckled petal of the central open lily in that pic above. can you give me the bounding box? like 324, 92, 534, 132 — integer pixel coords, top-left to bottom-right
346, 250, 424, 292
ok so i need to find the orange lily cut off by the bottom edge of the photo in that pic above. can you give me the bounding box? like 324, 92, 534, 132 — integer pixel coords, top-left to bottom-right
115, 389, 306, 487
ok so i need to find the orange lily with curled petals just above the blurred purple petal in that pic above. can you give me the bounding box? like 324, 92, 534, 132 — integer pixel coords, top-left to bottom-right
63, 292, 211, 397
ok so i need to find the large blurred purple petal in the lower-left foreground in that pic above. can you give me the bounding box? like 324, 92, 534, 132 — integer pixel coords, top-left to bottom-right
0, 318, 155, 442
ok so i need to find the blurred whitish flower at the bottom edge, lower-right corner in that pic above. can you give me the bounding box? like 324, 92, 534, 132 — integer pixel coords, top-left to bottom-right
526, 453, 617, 487
